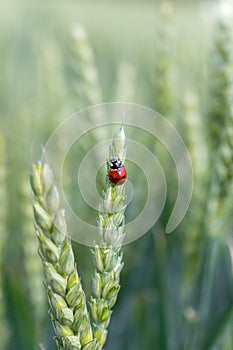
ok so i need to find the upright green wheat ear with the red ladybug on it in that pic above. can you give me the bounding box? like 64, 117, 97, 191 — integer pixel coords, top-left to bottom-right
90, 127, 126, 349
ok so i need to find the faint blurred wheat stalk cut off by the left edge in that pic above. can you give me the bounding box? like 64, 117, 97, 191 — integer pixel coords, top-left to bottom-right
0, 134, 9, 349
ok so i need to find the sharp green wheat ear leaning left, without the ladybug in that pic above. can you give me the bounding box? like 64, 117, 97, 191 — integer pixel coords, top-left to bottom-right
31, 162, 96, 350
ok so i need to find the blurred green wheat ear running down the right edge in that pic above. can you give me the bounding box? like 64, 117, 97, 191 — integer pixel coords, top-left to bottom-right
206, 13, 233, 236
